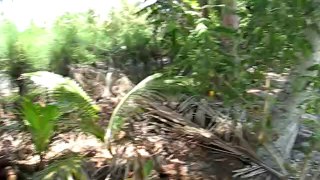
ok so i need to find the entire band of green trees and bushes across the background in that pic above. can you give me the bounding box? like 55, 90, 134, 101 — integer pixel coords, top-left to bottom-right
0, 0, 319, 148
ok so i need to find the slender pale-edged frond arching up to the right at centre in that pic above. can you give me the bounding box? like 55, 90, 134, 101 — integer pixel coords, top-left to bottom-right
105, 73, 162, 142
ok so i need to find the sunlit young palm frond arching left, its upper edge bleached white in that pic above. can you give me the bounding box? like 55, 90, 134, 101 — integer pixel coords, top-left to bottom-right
22, 71, 104, 140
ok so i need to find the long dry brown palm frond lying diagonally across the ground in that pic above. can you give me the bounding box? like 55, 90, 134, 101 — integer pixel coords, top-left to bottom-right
131, 100, 282, 178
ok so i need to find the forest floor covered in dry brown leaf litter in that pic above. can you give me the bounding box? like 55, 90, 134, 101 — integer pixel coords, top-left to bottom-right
0, 64, 320, 180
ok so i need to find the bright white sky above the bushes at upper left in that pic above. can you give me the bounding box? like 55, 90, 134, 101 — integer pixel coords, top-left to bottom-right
0, 0, 138, 30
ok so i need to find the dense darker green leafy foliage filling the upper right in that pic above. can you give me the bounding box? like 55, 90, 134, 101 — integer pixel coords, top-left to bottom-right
138, 1, 314, 99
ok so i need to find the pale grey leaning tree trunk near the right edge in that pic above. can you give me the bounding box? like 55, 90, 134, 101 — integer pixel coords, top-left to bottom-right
259, 25, 320, 172
